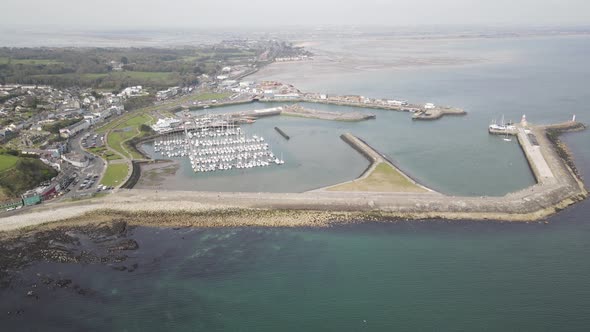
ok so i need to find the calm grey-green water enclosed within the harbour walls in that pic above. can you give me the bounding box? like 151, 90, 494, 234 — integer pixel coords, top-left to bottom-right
139, 103, 534, 196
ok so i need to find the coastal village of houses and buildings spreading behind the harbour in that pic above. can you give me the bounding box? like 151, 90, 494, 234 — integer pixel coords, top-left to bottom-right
0, 39, 311, 211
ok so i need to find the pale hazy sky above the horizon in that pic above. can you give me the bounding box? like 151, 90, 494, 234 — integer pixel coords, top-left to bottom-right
0, 0, 590, 28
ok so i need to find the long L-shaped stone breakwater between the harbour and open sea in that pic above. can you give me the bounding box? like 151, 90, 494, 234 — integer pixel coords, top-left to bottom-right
0, 123, 588, 231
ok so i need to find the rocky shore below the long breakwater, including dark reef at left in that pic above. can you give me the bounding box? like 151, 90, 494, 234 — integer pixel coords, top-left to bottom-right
0, 192, 584, 316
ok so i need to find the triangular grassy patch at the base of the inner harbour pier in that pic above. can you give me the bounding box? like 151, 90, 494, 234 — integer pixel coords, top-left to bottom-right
328, 162, 426, 192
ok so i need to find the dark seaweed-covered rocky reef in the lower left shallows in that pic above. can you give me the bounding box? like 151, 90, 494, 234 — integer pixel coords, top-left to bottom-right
0, 218, 139, 317
